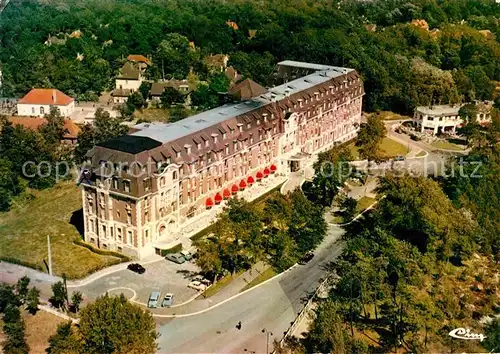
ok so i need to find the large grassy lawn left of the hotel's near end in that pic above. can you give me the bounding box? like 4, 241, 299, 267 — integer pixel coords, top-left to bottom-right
0, 182, 118, 278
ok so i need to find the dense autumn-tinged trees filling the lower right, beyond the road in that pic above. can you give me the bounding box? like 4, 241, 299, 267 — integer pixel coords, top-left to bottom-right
285, 115, 500, 354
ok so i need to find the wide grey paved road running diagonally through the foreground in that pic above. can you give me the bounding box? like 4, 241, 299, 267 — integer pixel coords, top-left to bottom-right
158, 226, 343, 353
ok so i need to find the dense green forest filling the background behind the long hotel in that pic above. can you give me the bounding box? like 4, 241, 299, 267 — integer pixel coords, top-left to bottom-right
0, 0, 500, 113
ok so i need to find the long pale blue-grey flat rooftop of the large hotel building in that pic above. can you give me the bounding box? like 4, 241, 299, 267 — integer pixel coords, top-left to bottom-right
132, 60, 353, 144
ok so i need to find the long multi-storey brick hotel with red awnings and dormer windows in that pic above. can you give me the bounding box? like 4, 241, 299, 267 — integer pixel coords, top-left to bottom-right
82, 61, 364, 259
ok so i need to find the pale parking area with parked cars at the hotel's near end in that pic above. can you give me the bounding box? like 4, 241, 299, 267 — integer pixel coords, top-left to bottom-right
70, 259, 199, 306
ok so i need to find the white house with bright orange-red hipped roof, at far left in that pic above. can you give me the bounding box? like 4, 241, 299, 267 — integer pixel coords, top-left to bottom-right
17, 88, 75, 117
